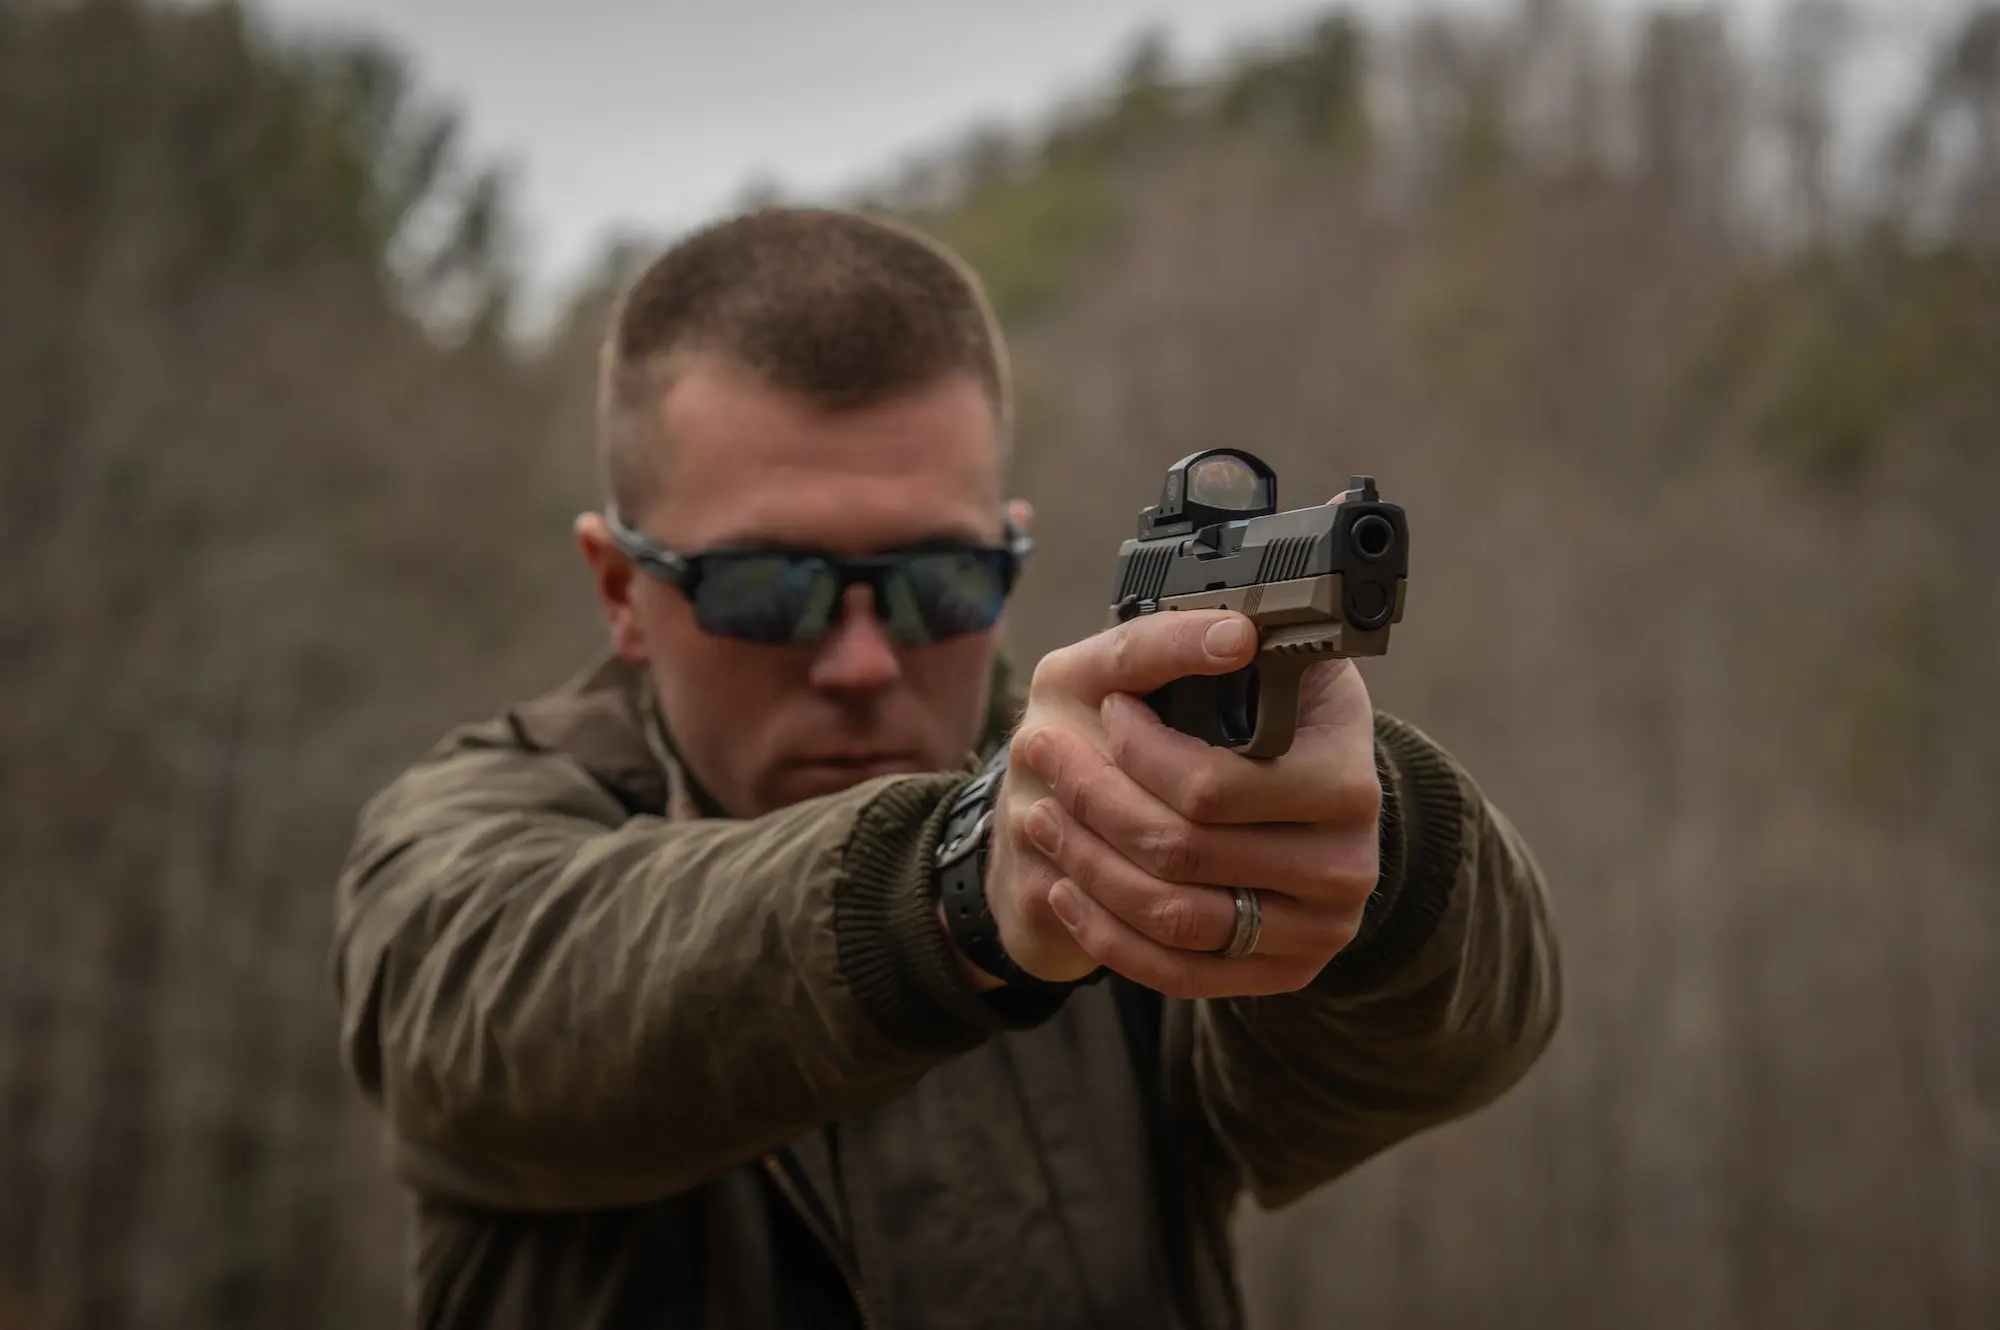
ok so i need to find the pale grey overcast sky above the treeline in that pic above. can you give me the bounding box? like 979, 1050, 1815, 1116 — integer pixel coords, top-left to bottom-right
258, 0, 1944, 304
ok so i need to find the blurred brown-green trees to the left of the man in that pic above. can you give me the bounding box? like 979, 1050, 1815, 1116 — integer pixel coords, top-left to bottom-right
0, 0, 580, 1326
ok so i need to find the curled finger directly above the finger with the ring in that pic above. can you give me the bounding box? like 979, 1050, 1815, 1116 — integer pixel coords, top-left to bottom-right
1020, 728, 1380, 904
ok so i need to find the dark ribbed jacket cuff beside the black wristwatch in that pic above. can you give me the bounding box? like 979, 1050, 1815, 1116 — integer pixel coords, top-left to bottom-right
834, 774, 1062, 1052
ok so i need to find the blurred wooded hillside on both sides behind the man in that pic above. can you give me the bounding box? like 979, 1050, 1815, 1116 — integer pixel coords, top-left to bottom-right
0, 0, 2000, 1330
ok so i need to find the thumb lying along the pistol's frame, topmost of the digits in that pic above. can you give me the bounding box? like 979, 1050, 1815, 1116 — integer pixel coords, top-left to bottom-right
1032, 610, 1256, 706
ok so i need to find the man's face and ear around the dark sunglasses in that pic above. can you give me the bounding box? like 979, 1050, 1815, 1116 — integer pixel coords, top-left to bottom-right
578, 358, 1002, 818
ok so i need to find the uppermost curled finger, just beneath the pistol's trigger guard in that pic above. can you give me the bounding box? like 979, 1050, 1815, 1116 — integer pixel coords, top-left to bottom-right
1100, 692, 1382, 826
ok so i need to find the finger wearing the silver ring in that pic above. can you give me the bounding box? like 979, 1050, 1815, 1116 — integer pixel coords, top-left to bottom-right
1024, 800, 1366, 960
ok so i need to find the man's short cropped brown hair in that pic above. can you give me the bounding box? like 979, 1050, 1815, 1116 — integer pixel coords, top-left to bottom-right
598, 208, 1012, 514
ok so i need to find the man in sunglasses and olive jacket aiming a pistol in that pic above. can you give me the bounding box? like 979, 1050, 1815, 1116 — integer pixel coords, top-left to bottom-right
336, 210, 1558, 1330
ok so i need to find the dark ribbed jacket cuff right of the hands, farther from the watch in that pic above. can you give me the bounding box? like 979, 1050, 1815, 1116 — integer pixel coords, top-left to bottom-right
1314, 712, 1466, 994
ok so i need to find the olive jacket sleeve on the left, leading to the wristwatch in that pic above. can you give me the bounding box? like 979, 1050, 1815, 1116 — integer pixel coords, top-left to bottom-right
334, 726, 1024, 1208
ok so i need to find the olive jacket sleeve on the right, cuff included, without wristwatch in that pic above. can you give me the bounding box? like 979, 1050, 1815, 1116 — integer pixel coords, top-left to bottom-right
1166, 716, 1560, 1206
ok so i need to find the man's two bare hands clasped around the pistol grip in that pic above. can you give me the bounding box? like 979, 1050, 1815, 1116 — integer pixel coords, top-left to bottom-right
986, 610, 1382, 998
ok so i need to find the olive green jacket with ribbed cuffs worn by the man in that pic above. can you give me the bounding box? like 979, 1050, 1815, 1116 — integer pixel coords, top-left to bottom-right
334, 662, 1558, 1330
